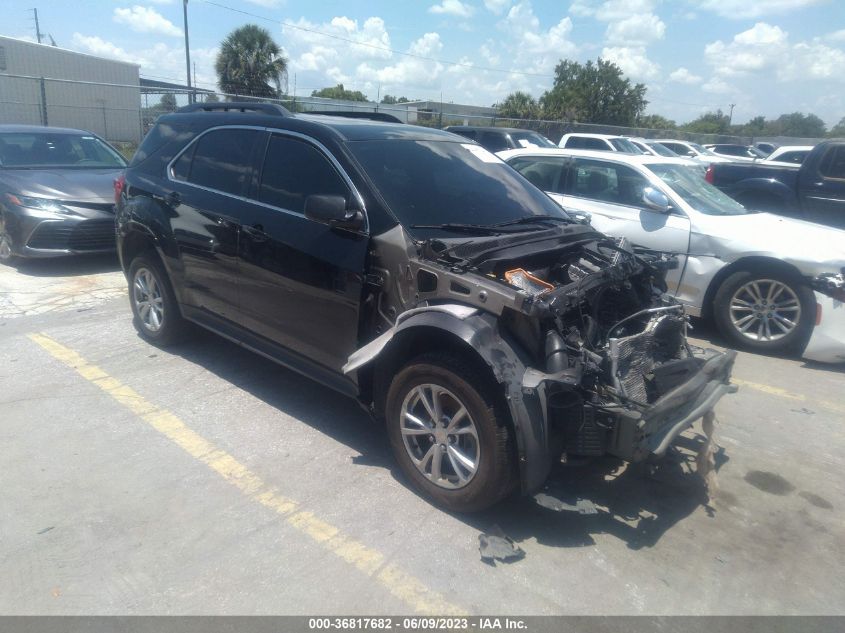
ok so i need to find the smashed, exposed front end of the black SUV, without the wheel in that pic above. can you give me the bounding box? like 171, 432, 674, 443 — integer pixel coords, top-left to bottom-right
345, 225, 736, 492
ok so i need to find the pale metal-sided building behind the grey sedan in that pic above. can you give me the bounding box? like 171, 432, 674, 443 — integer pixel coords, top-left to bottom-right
0, 36, 141, 142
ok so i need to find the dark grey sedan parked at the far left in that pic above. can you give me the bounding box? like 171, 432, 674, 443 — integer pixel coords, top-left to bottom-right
0, 125, 126, 262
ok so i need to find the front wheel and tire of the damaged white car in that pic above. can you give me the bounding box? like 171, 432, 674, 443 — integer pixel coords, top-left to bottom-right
713, 271, 816, 354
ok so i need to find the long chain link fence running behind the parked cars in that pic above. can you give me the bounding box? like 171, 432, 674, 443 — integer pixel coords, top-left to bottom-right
0, 74, 818, 154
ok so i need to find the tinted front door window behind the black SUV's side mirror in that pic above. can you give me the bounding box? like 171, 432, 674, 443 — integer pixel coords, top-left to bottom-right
258, 136, 349, 213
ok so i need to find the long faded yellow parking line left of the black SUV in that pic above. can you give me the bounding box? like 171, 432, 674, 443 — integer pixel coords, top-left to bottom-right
28, 334, 465, 615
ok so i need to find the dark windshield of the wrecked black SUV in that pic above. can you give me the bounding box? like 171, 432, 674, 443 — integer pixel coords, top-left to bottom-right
348, 139, 569, 234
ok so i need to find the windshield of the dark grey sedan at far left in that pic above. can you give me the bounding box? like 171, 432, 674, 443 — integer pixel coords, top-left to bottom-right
0, 132, 126, 169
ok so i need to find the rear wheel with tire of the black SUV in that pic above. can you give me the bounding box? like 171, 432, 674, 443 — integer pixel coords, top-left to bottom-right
128, 253, 187, 347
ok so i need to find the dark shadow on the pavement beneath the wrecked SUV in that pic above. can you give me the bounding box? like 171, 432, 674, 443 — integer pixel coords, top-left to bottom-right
163, 331, 727, 549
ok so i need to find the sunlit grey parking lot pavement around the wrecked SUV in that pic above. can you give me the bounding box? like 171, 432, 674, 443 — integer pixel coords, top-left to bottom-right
0, 257, 845, 615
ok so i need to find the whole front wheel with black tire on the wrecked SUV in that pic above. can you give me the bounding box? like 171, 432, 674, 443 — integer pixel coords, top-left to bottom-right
385, 354, 516, 512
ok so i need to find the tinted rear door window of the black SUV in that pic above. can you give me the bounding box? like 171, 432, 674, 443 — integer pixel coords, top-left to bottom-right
186, 129, 259, 195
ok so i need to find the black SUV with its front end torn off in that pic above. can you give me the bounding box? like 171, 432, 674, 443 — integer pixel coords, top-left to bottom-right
116, 103, 733, 511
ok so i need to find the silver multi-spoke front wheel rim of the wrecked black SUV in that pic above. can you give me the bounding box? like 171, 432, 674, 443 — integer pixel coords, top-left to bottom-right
399, 384, 481, 490
